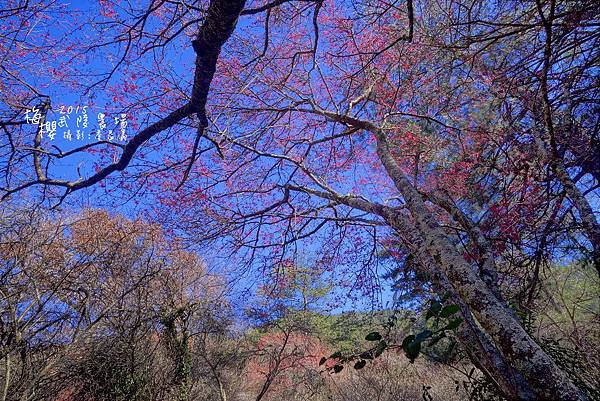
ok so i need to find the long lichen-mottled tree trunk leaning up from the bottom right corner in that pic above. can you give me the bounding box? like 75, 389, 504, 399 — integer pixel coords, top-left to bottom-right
374, 129, 586, 401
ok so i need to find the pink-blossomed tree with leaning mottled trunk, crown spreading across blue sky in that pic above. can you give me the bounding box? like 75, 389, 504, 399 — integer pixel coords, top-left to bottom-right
0, 0, 600, 400
